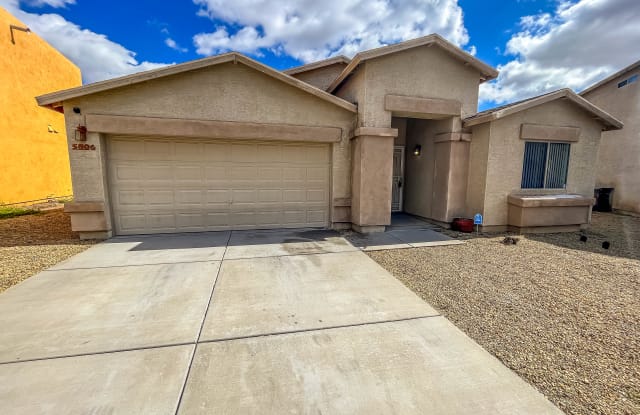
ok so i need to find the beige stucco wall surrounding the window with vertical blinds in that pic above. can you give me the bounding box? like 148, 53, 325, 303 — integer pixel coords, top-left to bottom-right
480, 100, 602, 226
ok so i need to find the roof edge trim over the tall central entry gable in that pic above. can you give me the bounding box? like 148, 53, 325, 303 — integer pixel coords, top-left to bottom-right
327, 33, 498, 92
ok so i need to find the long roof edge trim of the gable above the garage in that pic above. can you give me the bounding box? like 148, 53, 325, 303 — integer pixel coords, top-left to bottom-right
36, 52, 357, 113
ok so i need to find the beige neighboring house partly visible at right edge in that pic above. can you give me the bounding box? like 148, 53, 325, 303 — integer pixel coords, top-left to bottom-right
580, 61, 640, 218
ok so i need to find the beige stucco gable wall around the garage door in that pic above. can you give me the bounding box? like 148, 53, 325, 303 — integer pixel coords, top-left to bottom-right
64, 63, 355, 229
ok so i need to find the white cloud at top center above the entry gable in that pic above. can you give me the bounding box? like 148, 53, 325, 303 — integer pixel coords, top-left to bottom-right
193, 0, 469, 62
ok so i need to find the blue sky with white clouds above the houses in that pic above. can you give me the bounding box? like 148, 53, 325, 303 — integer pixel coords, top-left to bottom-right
0, 0, 640, 110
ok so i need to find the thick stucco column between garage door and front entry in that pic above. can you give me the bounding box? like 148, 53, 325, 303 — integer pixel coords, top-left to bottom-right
351, 127, 398, 233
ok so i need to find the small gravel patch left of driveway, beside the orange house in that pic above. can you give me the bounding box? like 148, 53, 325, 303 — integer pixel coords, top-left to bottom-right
0, 211, 95, 292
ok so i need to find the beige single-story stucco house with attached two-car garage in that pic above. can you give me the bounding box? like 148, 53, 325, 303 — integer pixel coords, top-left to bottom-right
37, 35, 622, 238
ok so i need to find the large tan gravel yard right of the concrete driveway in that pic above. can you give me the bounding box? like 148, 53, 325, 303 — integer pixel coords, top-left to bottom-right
368, 213, 640, 414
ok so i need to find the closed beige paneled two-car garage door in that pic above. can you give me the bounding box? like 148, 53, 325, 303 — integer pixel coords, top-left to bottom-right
107, 136, 331, 235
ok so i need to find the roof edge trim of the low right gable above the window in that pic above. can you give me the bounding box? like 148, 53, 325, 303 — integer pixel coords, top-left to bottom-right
464, 88, 623, 130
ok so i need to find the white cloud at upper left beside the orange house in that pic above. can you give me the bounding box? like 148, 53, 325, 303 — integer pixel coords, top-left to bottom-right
0, 0, 172, 83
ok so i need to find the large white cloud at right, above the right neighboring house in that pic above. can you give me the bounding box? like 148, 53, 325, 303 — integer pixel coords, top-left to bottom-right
480, 0, 640, 104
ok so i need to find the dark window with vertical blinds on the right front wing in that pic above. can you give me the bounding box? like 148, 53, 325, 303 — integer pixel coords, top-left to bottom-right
521, 141, 570, 189
